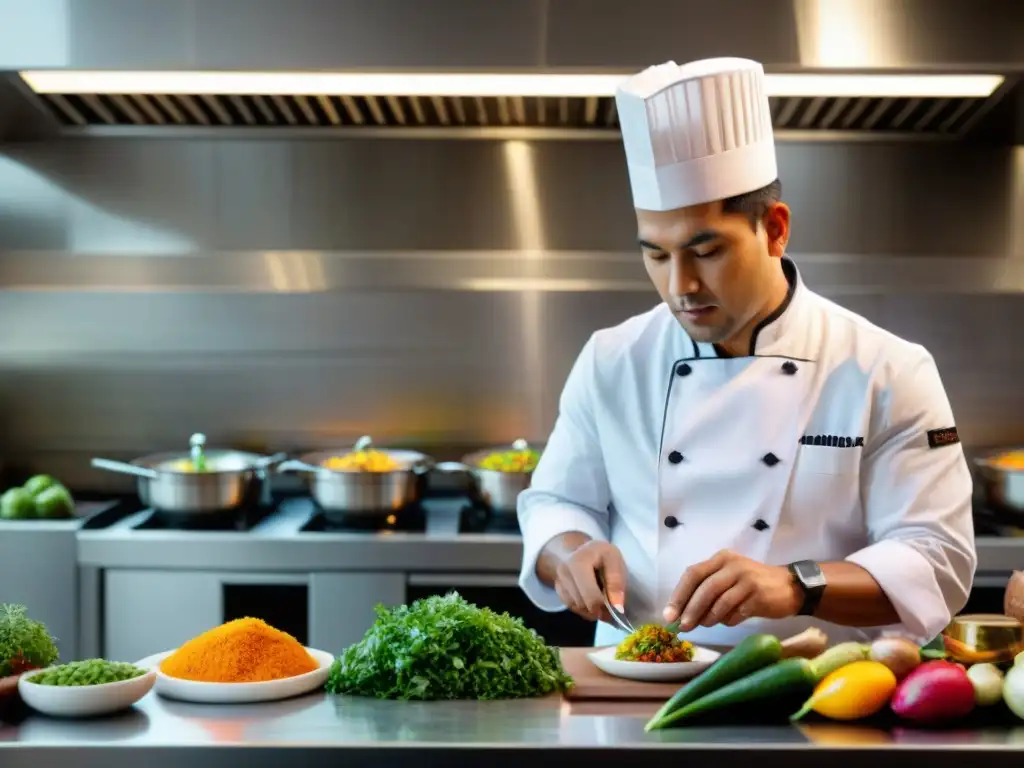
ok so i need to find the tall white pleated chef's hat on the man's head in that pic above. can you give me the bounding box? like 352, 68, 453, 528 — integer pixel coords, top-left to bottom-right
615, 58, 777, 211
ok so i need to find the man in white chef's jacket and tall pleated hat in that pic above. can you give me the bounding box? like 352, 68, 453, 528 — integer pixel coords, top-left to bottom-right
518, 58, 977, 645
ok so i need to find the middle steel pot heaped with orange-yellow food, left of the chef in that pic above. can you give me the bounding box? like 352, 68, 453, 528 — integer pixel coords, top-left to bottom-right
278, 435, 433, 515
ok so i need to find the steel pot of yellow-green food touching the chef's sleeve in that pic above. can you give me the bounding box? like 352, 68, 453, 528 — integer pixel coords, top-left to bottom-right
436, 439, 543, 514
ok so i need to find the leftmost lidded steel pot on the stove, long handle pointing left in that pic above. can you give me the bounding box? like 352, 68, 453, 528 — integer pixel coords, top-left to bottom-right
92, 433, 287, 515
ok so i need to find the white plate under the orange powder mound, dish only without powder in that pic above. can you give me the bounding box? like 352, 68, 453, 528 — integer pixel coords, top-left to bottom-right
135, 648, 334, 703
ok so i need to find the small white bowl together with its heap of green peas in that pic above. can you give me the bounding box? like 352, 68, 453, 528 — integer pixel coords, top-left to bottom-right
17, 658, 157, 718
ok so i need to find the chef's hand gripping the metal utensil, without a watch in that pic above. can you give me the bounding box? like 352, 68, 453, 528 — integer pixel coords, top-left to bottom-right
555, 541, 626, 623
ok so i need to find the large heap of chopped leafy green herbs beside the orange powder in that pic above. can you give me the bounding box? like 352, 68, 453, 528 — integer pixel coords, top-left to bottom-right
327, 592, 572, 699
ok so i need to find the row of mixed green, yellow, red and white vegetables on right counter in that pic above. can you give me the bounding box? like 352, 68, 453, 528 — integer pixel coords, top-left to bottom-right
645, 635, 1024, 731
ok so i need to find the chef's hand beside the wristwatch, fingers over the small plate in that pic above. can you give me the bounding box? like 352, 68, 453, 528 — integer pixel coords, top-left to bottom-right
665, 550, 803, 632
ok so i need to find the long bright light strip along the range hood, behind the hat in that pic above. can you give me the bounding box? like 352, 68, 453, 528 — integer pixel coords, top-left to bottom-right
20, 70, 1002, 98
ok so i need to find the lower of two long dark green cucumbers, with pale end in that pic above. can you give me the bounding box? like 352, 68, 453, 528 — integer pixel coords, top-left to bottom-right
657, 642, 869, 728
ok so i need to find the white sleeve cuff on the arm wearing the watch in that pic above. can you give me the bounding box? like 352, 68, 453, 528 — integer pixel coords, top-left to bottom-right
846, 539, 951, 644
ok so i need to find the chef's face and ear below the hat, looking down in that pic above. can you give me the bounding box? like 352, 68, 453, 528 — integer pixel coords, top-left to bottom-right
636, 202, 790, 344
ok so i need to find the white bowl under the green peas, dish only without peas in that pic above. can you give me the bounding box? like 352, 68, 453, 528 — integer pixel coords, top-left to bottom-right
17, 668, 157, 718
